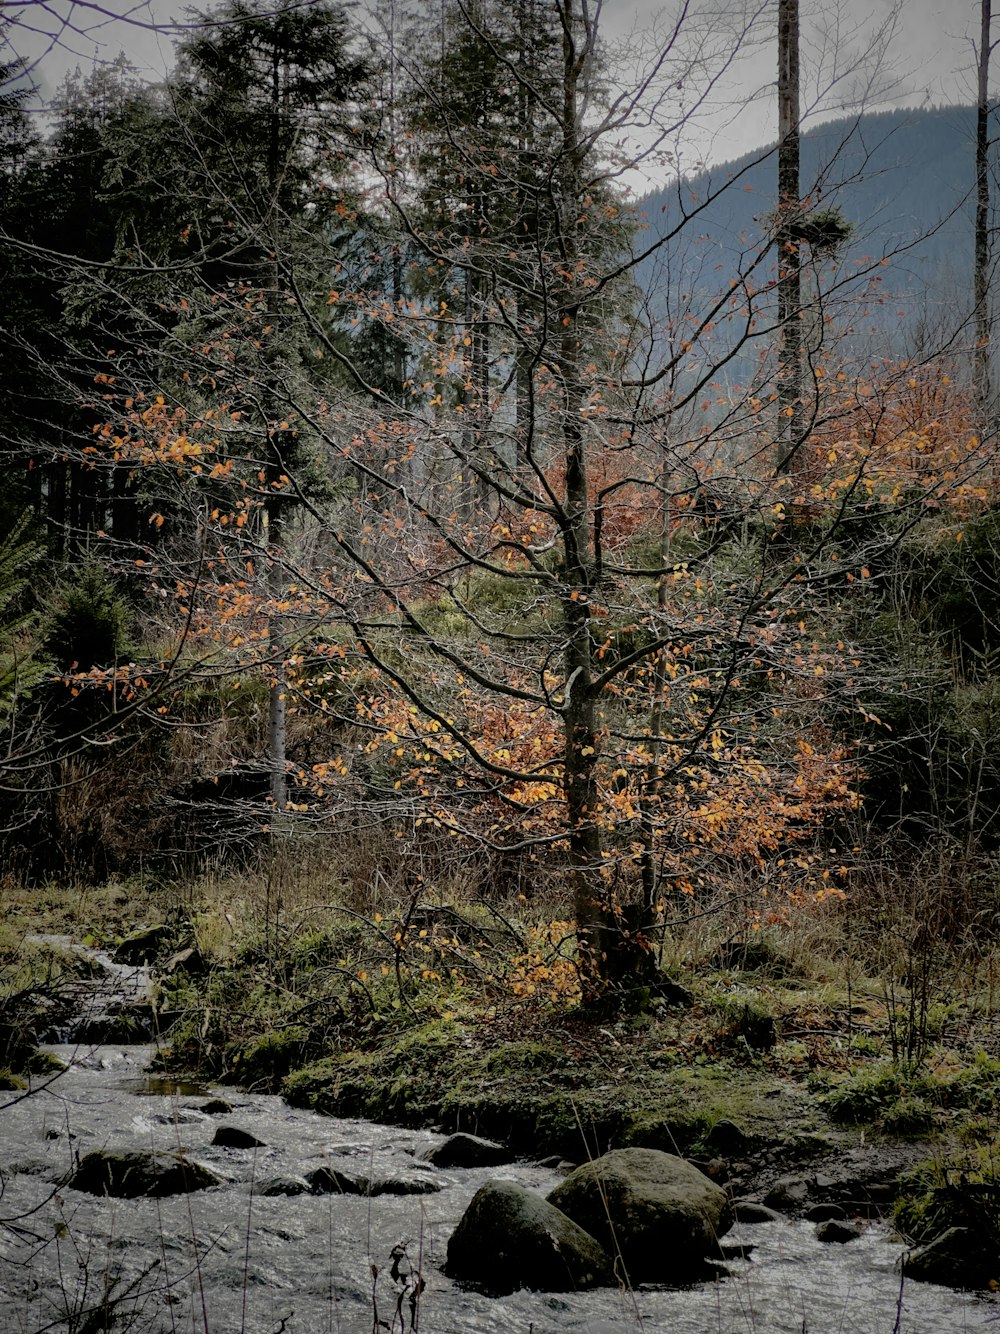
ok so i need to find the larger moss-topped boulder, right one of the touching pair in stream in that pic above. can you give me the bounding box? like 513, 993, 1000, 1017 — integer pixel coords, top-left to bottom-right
548, 1149, 733, 1283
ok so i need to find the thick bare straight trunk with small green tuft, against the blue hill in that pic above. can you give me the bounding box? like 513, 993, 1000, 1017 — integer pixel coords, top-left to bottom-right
775, 0, 803, 472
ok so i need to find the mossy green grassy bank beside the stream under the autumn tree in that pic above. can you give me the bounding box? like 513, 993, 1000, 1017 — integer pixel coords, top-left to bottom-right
3, 859, 1000, 1184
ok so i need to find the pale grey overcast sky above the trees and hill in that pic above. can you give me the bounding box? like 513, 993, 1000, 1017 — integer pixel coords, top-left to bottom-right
0, 0, 979, 188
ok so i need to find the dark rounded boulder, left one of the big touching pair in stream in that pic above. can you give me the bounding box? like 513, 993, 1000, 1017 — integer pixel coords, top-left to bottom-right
448, 1181, 611, 1294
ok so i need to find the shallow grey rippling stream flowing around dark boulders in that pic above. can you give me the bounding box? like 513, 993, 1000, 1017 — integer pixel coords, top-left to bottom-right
0, 949, 1000, 1334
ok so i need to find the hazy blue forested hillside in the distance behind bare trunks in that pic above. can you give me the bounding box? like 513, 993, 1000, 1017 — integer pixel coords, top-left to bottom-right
639, 107, 976, 373
